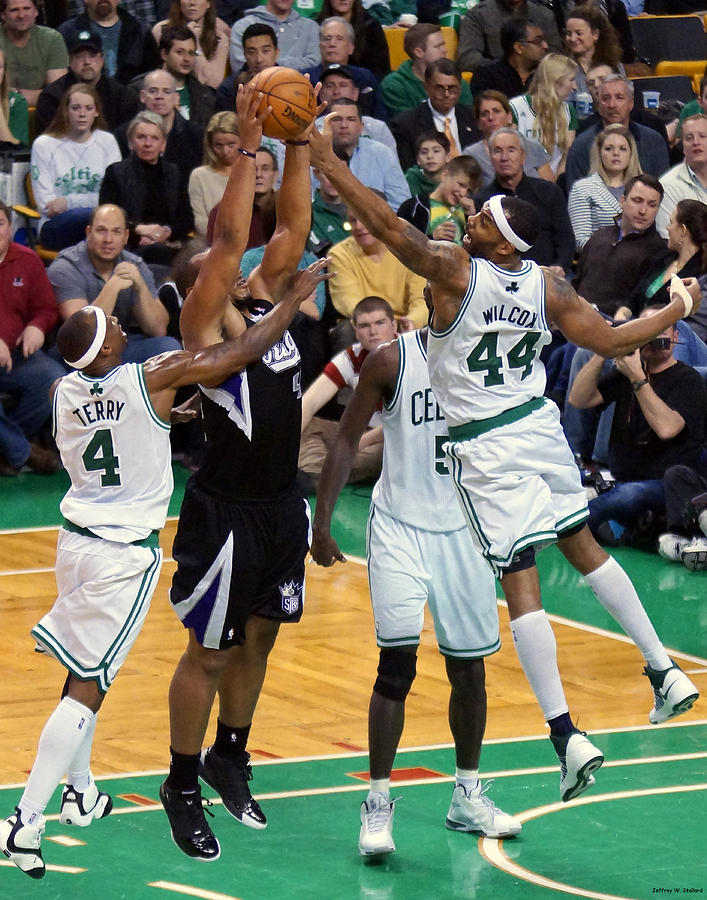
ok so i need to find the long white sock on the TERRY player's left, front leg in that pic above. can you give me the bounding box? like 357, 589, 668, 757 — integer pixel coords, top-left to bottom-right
18, 697, 94, 822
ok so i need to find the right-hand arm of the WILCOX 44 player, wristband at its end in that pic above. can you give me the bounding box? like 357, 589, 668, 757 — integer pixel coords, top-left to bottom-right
543, 269, 699, 359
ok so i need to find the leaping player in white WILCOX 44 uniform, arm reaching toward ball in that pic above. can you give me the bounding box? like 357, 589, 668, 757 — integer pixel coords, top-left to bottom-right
309, 119, 699, 801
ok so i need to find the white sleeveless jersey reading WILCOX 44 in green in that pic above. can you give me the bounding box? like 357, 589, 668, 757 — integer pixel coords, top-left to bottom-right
427, 258, 552, 426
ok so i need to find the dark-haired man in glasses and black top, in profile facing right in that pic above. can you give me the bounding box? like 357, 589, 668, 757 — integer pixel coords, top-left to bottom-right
471, 18, 548, 97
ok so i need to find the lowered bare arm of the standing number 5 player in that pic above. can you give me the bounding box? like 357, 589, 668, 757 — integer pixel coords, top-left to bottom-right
310, 341, 400, 566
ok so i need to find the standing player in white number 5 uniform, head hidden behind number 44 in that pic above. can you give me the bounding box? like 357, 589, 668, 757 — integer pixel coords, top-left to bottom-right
311, 328, 521, 856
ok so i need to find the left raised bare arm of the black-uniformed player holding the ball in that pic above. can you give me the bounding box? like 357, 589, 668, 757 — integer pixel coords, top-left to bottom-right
179, 84, 270, 350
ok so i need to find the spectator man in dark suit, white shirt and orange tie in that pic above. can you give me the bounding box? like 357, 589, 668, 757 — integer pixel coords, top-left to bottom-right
390, 58, 481, 171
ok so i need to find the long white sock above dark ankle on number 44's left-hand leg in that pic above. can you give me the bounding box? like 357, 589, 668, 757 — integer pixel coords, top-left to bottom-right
511, 609, 569, 722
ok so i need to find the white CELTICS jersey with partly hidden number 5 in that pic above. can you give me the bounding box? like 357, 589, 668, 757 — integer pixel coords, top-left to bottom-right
372, 331, 465, 531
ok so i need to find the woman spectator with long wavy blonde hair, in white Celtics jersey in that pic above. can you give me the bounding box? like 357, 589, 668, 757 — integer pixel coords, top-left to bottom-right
511, 53, 577, 178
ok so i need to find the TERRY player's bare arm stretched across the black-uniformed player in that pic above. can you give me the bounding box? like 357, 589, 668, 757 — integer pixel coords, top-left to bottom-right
144, 259, 330, 420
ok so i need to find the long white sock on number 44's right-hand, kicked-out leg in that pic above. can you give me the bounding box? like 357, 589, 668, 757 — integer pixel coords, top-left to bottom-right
585, 556, 672, 672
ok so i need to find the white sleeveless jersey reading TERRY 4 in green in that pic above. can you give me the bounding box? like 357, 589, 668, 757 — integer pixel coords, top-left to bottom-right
53, 363, 173, 543
